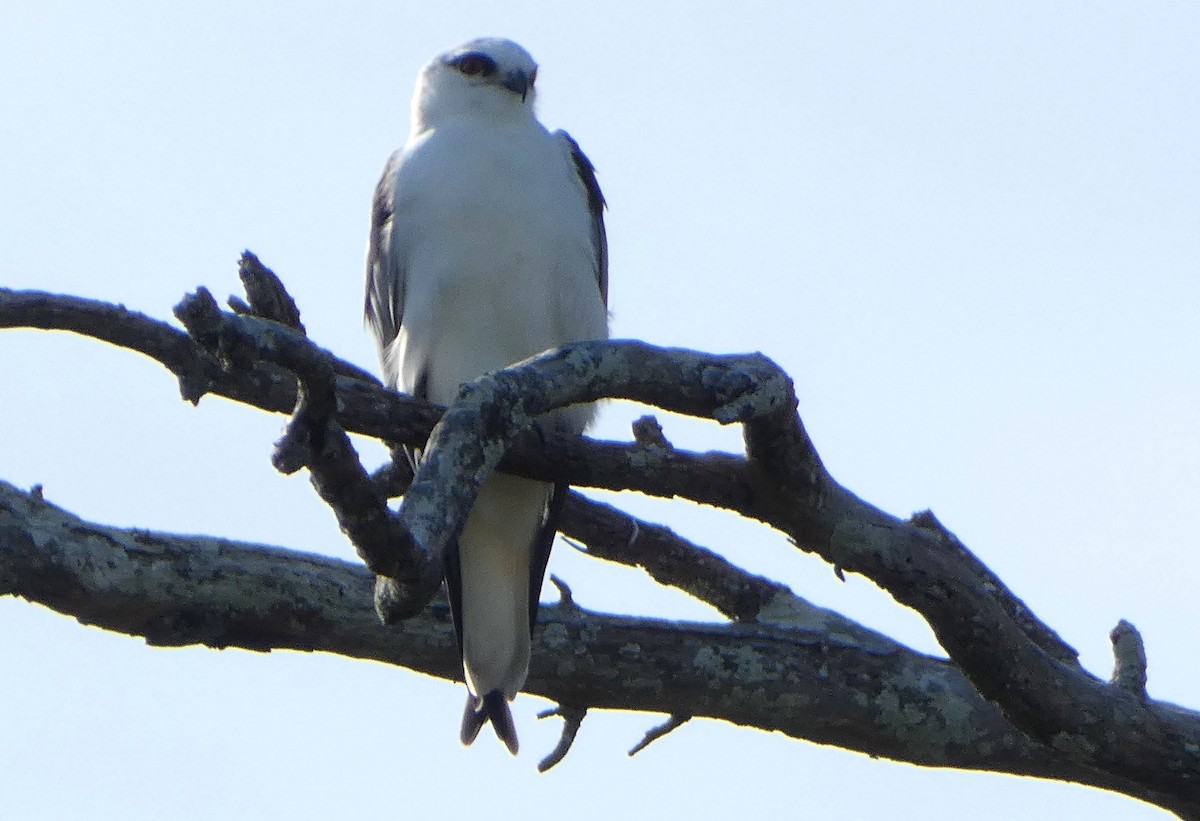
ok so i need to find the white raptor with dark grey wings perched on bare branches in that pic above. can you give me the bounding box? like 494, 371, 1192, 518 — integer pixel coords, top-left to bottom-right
366, 37, 608, 755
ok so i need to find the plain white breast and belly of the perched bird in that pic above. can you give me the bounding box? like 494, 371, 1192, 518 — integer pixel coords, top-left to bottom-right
391, 119, 606, 410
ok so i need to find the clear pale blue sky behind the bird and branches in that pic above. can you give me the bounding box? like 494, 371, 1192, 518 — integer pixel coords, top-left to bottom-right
0, 0, 1200, 821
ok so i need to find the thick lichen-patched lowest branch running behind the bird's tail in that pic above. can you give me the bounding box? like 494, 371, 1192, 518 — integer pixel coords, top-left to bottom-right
0, 483, 1190, 807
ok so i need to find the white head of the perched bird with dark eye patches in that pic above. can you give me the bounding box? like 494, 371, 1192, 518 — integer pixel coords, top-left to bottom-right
413, 37, 538, 127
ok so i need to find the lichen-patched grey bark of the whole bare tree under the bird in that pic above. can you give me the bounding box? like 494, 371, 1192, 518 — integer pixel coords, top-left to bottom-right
0, 278, 1200, 817
